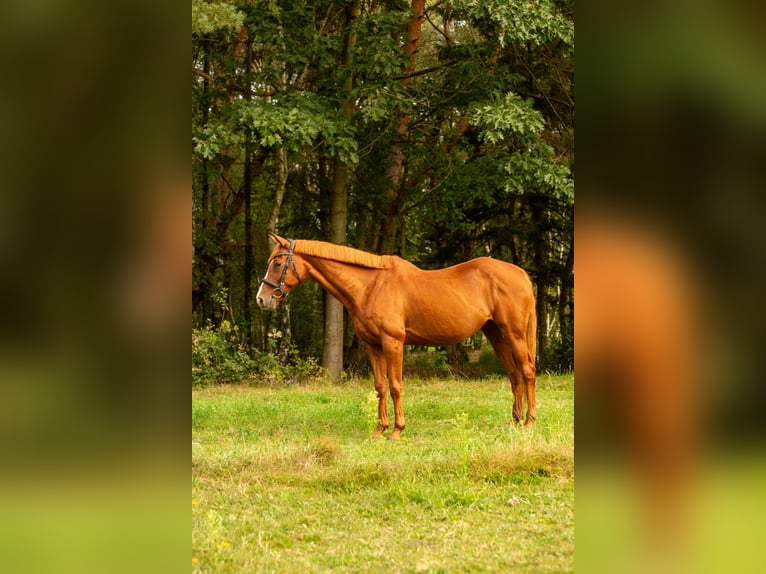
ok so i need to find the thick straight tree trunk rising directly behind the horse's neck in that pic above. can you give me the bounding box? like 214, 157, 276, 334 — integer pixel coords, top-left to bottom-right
322, 0, 361, 382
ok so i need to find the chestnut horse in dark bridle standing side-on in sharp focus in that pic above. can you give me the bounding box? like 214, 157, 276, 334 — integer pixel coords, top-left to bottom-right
256, 233, 537, 439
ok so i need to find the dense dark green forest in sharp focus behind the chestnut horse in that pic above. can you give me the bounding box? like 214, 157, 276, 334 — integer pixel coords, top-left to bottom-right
192, 0, 574, 383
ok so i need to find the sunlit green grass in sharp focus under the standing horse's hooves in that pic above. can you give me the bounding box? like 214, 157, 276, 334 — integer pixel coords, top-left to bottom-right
192, 375, 574, 573
